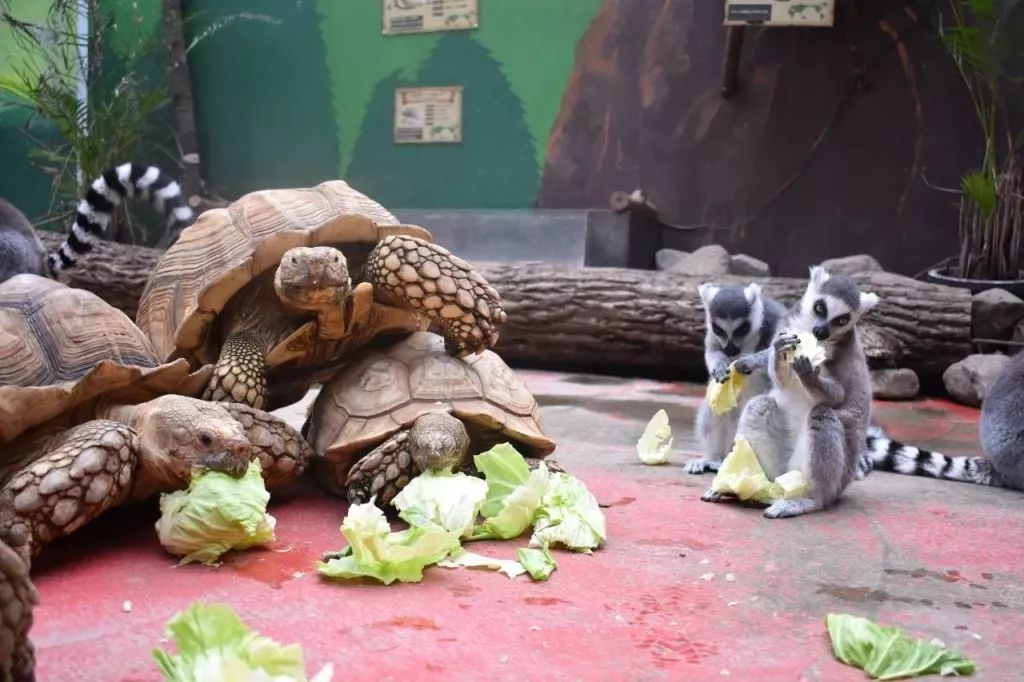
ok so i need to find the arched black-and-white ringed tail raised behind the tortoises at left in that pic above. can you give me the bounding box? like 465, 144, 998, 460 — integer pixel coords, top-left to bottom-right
46, 163, 193, 276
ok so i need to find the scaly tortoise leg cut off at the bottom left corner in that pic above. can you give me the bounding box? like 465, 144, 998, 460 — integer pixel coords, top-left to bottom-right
0, 543, 39, 682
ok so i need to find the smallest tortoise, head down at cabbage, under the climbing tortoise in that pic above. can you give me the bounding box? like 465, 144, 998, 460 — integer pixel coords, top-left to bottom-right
304, 332, 557, 505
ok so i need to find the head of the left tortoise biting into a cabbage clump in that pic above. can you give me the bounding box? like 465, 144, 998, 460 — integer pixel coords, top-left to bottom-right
108, 395, 252, 497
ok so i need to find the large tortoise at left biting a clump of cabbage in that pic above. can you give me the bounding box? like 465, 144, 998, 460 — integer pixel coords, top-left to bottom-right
0, 274, 311, 560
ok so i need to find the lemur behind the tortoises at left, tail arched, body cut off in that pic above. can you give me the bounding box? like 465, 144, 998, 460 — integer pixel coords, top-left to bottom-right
0, 163, 194, 281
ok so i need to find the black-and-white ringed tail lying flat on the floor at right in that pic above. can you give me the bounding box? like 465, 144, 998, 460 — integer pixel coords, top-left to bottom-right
861, 426, 1001, 485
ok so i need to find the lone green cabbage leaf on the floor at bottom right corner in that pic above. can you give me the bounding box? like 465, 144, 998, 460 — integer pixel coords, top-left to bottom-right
825, 613, 975, 680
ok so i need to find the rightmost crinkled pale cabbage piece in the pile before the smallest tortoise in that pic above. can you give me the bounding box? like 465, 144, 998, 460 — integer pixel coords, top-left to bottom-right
529, 473, 607, 553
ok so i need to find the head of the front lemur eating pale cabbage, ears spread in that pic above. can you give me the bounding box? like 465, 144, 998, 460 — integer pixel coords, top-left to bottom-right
801, 267, 879, 342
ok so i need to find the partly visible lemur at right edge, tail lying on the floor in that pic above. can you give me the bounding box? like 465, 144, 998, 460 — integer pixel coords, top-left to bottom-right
867, 352, 1024, 491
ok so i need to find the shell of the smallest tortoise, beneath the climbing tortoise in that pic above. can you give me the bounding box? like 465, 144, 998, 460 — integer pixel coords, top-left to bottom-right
308, 332, 555, 467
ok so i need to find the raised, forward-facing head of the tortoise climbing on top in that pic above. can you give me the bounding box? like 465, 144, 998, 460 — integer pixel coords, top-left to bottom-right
273, 247, 352, 310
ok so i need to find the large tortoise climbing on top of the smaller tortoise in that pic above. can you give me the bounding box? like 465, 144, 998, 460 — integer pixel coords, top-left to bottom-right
136, 180, 506, 409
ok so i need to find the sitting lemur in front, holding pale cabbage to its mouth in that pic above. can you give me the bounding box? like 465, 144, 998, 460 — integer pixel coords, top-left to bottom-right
701, 267, 879, 518
